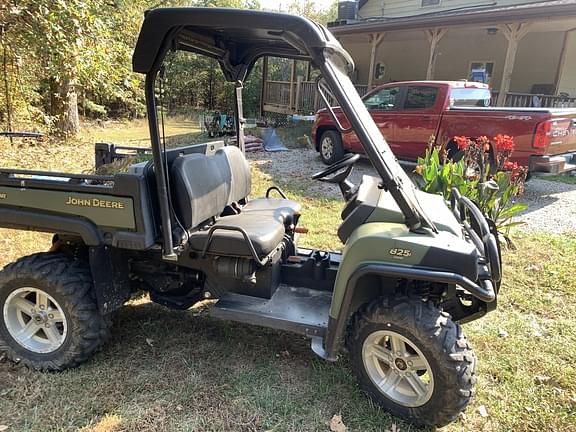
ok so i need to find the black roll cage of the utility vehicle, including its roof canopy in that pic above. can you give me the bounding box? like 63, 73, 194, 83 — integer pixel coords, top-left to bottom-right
132, 8, 436, 259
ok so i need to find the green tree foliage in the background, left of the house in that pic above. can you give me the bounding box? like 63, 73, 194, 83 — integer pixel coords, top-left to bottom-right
0, 0, 336, 132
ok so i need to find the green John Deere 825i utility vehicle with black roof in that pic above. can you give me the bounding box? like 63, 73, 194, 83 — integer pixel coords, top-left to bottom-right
0, 8, 501, 425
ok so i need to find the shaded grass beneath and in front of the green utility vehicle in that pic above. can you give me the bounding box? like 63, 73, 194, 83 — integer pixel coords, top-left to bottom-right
0, 303, 432, 431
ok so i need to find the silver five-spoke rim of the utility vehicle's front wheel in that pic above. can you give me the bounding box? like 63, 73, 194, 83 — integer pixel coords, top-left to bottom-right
362, 330, 434, 407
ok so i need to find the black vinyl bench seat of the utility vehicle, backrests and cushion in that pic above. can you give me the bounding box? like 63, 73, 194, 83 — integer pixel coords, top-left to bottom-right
170, 147, 301, 259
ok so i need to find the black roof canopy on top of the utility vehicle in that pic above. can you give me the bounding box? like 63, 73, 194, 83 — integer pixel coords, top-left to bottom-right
132, 8, 353, 81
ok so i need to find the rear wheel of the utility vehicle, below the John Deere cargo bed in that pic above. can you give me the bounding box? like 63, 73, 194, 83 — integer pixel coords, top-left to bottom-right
0, 253, 108, 370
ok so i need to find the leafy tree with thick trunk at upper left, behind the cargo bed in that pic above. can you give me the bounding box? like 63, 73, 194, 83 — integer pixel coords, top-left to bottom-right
1, 0, 153, 135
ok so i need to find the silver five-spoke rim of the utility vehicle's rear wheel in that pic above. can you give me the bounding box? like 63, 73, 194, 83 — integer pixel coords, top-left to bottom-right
3, 287, 68, 354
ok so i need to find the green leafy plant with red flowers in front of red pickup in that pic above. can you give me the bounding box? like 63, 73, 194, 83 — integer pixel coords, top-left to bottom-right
416, 135, 528, 240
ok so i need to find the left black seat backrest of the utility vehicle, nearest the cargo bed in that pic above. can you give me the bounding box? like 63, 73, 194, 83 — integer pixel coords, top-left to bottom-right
170, 152, 230, 230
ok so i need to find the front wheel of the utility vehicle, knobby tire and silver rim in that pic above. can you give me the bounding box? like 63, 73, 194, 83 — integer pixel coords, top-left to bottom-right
347, 298, 476, 427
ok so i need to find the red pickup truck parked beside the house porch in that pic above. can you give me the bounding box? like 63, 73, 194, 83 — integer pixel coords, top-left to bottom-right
312, 81, 576, 173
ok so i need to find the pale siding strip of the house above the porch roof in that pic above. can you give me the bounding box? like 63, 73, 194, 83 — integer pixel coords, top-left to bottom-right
358, 0, 542, 18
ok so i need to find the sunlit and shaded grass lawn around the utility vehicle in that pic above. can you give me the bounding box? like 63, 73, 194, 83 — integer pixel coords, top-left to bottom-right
0, 123, 576, 432
